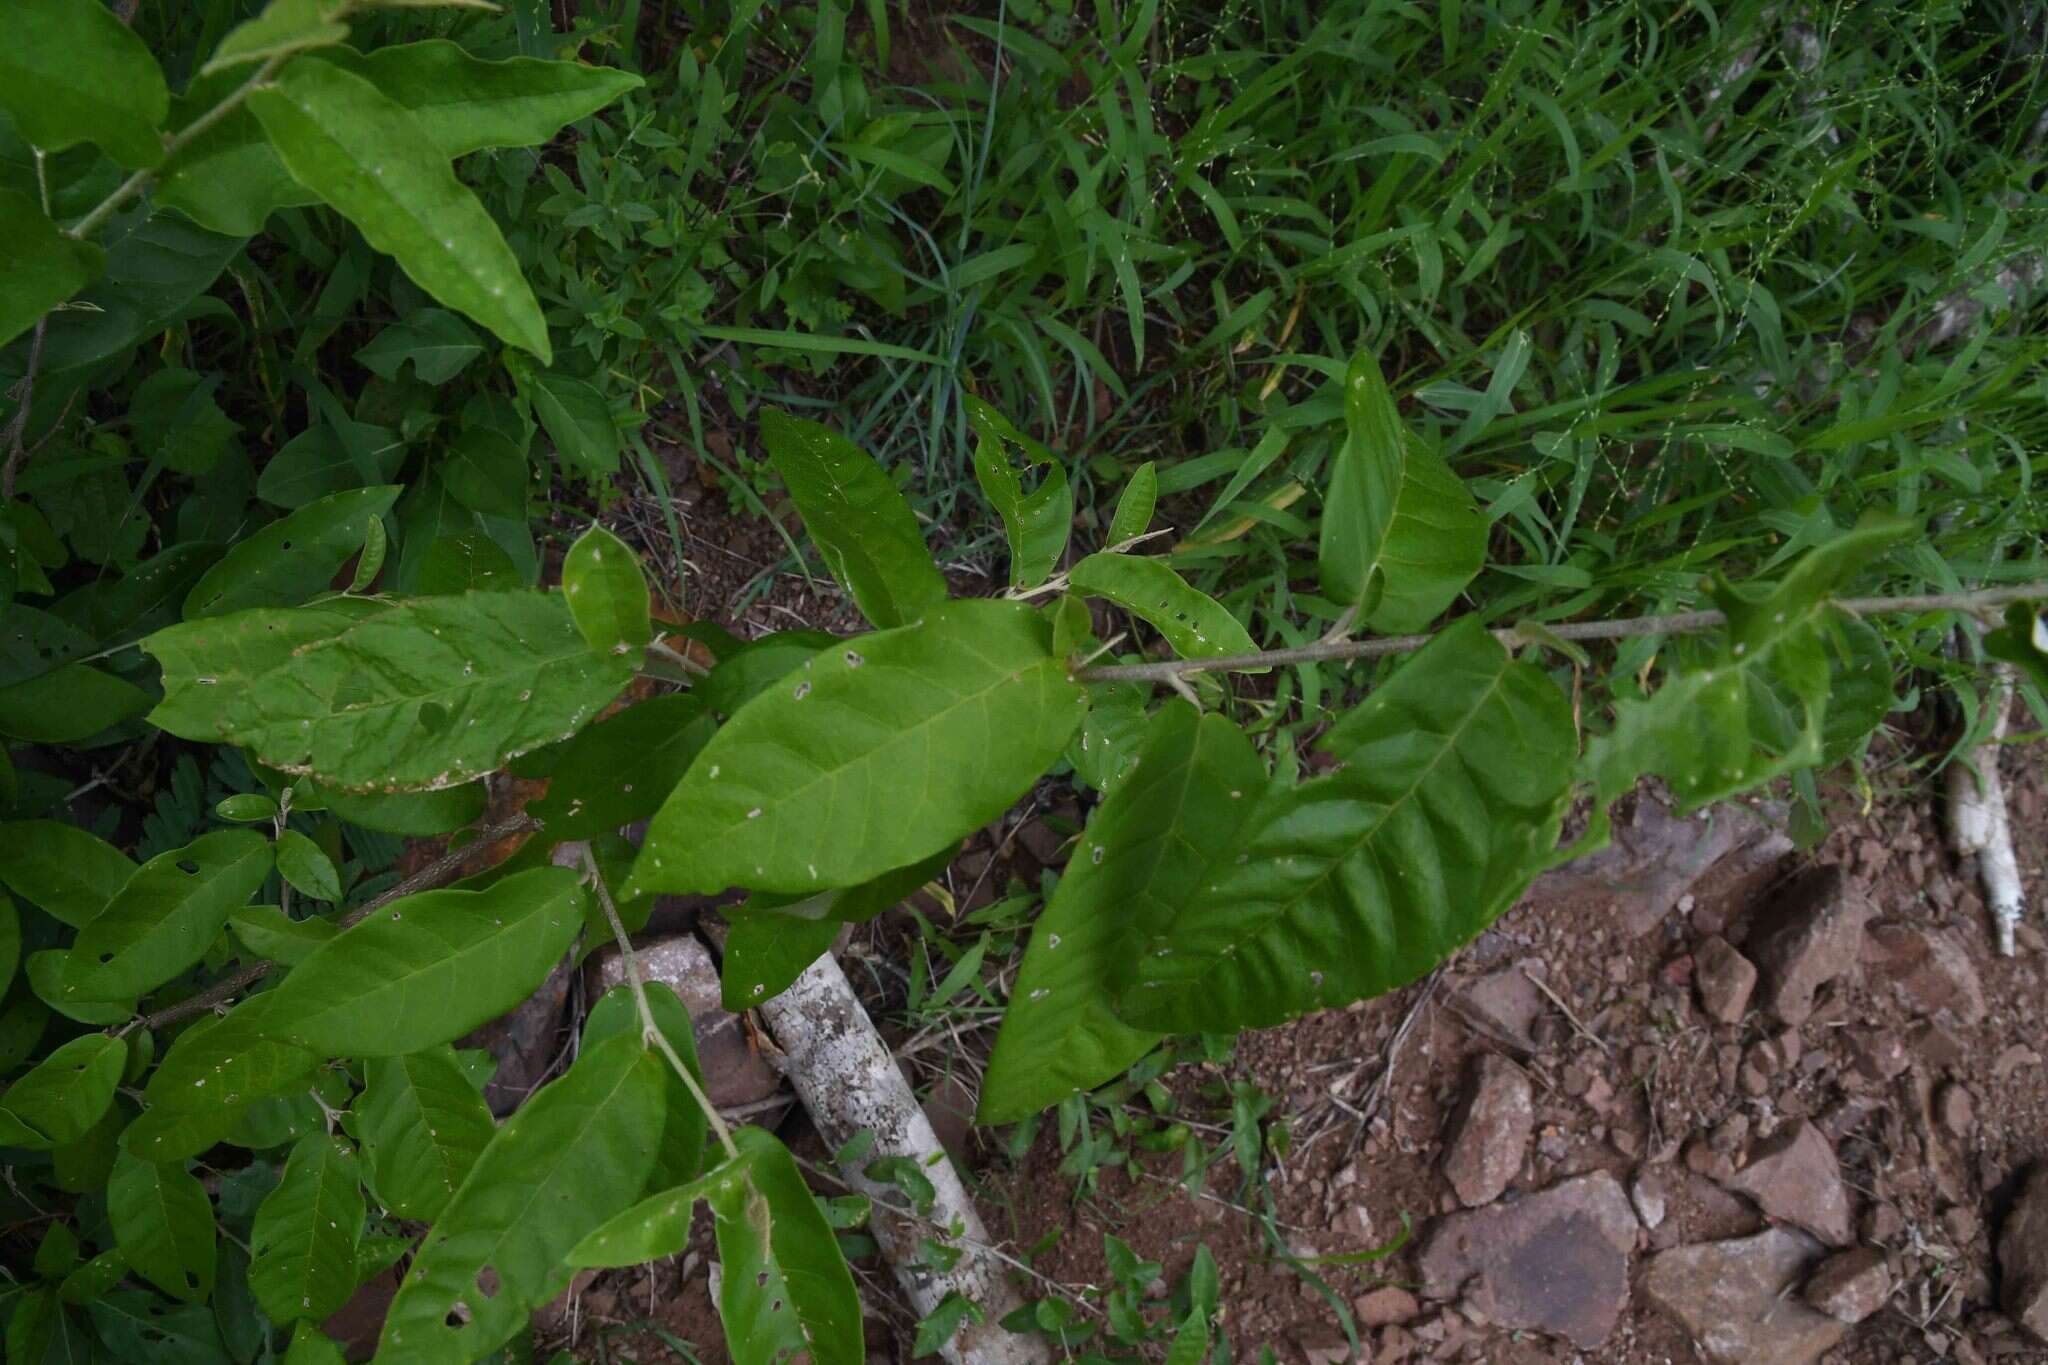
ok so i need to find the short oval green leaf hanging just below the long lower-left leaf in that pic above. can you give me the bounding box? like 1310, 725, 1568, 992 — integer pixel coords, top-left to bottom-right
354, 1044, 498, 1222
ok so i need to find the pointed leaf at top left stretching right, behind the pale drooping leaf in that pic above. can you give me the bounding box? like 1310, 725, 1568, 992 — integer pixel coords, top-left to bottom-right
319, 39, 641, 160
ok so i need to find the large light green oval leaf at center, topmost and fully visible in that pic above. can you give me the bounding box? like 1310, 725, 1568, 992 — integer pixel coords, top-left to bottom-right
625, 602, 1087, 896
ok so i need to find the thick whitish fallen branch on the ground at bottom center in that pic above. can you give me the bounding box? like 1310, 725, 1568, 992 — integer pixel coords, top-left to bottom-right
758, 954, 1053, 1365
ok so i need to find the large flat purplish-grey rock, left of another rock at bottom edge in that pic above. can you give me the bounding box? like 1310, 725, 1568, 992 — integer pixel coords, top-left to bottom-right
1417, 1171, 1638, 1349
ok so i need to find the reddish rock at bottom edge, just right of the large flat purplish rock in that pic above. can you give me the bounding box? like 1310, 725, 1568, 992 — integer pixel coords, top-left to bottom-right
1642, 1228, 1849, 1365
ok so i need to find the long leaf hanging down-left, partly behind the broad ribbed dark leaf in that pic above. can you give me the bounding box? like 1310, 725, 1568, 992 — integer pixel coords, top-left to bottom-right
975, 702, 1266, 1124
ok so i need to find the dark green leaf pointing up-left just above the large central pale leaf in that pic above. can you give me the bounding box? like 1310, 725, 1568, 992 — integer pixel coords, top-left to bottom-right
760, 407, 946, 630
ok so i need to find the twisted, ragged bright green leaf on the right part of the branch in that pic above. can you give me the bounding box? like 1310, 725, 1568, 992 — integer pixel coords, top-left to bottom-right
1585, 516, 1911, 810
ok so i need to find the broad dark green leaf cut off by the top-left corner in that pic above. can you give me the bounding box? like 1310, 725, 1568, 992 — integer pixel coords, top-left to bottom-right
0, 0, 170, 167
